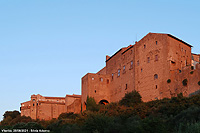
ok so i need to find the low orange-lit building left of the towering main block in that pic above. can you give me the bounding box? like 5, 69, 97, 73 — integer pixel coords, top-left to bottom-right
20, 94, 81, 120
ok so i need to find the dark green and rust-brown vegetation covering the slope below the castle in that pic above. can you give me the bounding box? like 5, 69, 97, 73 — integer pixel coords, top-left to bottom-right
0, 91, 200, 133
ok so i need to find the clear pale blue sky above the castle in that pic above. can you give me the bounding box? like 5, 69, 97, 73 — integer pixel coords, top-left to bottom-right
0, 0, 200, 120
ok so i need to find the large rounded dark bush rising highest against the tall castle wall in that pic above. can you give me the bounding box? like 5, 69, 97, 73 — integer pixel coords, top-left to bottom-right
119, 90, 142, 107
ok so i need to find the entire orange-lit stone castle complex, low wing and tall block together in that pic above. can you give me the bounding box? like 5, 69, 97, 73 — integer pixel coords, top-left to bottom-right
21, 33, 200, 120
